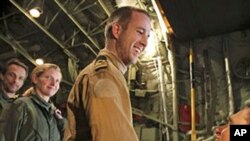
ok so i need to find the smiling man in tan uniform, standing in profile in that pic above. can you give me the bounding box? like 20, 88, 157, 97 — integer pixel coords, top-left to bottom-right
64, 7, 151, 141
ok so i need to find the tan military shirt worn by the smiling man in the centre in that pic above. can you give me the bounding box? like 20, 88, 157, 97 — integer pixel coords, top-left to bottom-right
64, 49, 138, 141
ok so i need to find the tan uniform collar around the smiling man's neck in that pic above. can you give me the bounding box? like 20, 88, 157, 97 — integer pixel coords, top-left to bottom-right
98, 48, 127, 74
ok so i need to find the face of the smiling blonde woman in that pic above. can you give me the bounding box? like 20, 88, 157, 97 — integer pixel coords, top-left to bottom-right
34, 68, 62, 97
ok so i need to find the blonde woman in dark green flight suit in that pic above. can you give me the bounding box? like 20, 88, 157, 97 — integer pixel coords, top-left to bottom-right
1, 63, 65, 141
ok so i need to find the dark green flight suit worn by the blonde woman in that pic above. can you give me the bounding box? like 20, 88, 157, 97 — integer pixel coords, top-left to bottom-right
0, 94, 65, 141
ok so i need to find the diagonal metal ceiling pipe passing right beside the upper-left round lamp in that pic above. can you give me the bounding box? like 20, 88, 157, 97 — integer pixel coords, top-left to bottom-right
10, 0, 79, 62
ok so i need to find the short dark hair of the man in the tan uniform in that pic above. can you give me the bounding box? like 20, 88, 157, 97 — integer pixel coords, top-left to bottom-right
104, 6, 150, 39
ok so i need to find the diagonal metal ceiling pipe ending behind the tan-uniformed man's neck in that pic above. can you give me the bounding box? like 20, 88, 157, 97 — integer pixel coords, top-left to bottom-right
54, 0, 100, 50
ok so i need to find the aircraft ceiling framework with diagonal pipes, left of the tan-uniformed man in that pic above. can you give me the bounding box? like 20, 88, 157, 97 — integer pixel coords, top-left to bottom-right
0, 0, 164, 99
